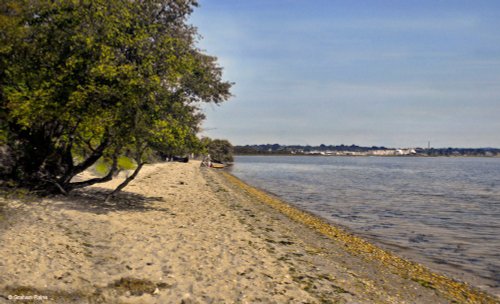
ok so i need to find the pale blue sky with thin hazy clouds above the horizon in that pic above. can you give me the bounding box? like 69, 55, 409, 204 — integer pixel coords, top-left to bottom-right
190, 0, 500, 147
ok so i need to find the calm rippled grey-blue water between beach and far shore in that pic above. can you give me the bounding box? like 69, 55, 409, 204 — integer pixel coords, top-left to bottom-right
232, 156, 500, 295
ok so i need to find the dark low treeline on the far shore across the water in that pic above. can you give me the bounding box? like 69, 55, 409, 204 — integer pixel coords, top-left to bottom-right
234, 144, 500, 157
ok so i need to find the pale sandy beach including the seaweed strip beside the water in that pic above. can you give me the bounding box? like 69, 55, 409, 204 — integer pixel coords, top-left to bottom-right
0, 161, 499, 303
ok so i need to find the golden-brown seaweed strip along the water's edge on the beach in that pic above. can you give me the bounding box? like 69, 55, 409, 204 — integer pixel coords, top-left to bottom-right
221, 172, 500, 303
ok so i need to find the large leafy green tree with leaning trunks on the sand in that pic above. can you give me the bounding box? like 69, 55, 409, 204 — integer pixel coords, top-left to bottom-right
0, 0, 231, 193
